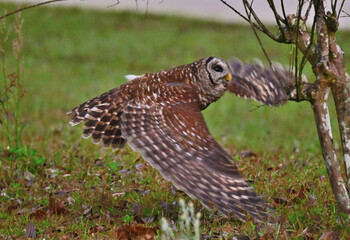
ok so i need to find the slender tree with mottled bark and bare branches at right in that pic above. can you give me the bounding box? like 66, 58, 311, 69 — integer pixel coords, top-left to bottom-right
221, 0, 350, 217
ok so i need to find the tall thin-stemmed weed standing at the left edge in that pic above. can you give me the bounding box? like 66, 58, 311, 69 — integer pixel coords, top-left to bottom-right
0, 8, 25, 149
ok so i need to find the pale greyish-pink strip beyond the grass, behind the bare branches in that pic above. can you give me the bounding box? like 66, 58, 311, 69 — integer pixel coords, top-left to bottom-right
0, 0, 350, 29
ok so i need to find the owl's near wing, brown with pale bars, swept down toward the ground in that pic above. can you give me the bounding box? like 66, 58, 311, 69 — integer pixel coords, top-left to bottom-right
121, 84, 267, 220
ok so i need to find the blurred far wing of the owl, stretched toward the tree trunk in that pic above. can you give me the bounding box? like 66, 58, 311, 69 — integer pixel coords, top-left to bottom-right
228, 59, 304, 106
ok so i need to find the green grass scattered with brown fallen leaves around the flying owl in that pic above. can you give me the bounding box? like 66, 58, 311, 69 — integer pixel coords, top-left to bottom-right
0, 3, 350, 239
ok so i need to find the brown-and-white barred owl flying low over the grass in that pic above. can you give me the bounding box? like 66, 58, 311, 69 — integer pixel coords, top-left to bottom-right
69, 57, 294, 220
